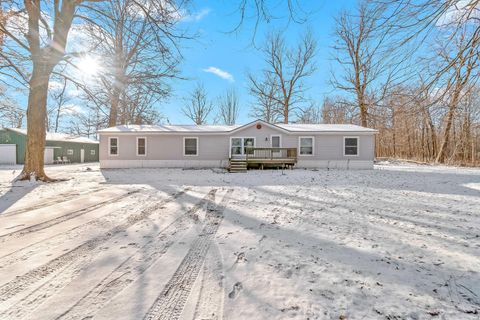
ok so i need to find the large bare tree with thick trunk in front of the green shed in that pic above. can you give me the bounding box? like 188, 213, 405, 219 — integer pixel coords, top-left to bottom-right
0, 0, 186, 181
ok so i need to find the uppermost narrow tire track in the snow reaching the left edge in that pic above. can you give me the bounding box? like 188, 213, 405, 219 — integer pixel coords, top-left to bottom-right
0, 190, 138, 242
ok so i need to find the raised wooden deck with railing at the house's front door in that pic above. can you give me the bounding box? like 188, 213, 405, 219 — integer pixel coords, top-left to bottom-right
231, 148, 297, 169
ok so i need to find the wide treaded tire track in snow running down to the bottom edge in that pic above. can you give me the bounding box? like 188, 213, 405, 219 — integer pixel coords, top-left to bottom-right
144, 189, 233, 320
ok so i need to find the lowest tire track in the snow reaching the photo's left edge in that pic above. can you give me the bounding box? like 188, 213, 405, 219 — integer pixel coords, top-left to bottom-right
0, 190, 186, 302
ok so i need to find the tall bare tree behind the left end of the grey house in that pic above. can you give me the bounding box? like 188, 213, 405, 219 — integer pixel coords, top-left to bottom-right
79, 0, 186, 126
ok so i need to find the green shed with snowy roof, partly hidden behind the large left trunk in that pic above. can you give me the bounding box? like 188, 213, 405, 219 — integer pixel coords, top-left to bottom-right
0, 128, 99, 164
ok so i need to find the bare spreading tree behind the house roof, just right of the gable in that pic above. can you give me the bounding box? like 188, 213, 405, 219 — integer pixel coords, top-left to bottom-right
248, 32, 317, 123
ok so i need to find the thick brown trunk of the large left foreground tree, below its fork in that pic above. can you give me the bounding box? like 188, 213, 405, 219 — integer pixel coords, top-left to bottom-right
20, 64, 53, 182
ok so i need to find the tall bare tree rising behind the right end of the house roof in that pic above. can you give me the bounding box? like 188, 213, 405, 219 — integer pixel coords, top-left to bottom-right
331, 1, 402, 127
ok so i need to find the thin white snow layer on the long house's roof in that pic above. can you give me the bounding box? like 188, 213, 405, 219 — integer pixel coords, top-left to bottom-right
98, 120, 376, 133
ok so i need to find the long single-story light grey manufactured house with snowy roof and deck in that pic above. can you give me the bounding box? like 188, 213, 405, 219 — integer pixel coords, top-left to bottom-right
99, 120, 377, 171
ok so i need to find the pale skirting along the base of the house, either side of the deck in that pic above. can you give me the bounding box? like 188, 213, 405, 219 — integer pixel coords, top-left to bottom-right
100, 159, 373, 170
